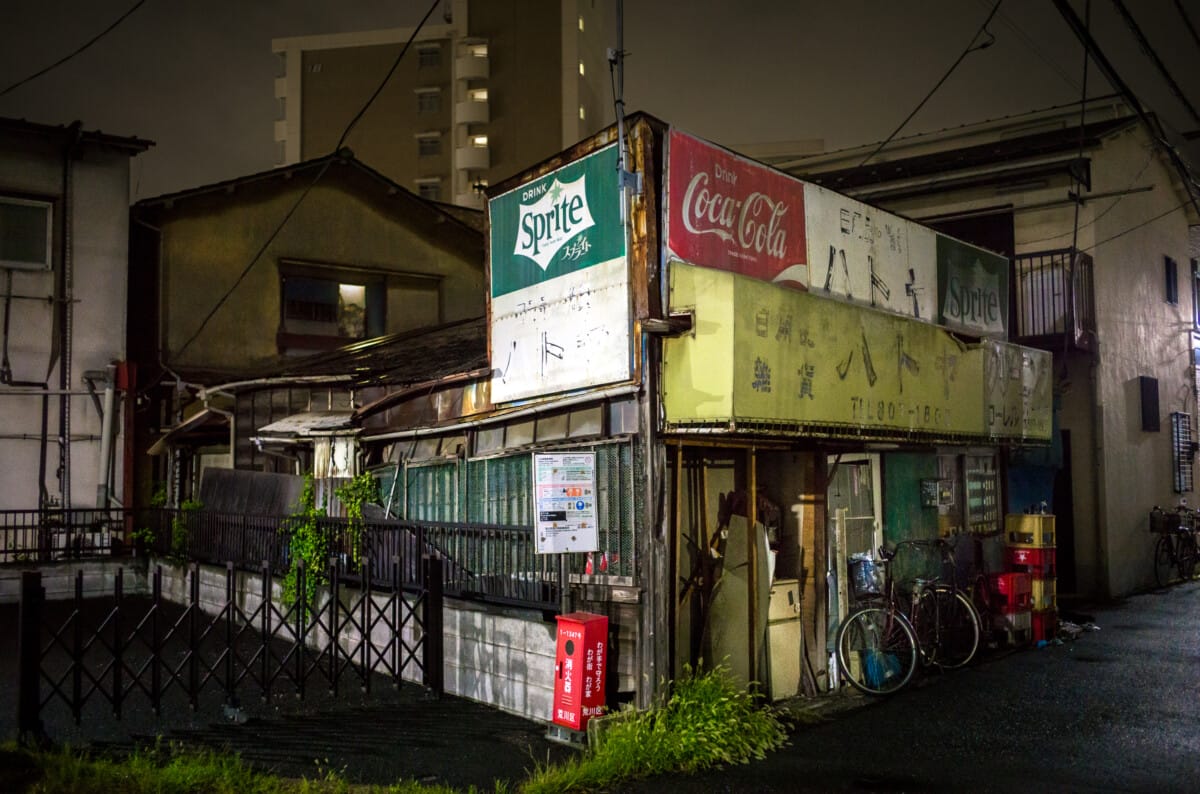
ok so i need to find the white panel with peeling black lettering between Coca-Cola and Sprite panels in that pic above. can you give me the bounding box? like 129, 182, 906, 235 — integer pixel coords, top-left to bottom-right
804, 185, 937, 323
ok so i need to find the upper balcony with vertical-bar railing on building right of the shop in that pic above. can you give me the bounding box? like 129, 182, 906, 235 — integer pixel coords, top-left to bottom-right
1009, 248, 1097, 350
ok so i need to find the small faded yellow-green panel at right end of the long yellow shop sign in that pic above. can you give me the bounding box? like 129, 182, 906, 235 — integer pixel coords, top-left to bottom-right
980, 341, 1054, 441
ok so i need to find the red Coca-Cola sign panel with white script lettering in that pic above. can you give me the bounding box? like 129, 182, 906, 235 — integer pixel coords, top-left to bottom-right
666, 130, 809, 289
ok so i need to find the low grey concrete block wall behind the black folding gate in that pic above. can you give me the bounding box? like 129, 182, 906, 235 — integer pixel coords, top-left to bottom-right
0, 560, 554, 721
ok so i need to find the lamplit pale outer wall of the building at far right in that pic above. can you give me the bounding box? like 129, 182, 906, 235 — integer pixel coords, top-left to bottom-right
1091, 130, 1195, 595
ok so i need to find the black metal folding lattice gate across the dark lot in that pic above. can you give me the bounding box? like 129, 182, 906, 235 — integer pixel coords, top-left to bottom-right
17, 558, 444, 740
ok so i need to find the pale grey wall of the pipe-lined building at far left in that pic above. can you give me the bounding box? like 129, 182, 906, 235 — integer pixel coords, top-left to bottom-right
0, 138, 130, 510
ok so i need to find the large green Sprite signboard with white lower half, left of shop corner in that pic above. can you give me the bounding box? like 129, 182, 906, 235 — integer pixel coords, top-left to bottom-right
488, 145, 630, 403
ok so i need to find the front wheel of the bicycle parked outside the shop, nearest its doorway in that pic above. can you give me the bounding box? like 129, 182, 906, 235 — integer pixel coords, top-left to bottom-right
836, 607, 917, 694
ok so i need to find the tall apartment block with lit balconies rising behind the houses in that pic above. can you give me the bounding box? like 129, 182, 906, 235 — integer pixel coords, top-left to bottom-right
271, 0, 616, 207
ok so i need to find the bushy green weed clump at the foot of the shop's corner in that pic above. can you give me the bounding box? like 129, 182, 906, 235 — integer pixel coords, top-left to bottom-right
521, 666, 787, 794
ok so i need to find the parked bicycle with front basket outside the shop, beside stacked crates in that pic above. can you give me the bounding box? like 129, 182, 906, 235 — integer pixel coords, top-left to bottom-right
835, 540, 980, 694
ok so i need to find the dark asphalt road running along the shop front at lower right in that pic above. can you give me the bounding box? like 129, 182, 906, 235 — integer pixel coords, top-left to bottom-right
622, 582, 1200, 794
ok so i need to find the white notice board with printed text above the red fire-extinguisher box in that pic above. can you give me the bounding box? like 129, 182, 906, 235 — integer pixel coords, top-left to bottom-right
533, 452, 600, 554
